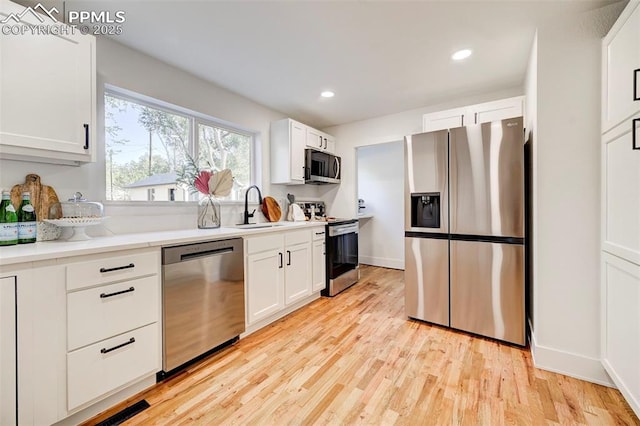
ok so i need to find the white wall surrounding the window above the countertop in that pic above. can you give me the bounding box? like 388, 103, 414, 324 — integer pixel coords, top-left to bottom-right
0, 37, 319, 233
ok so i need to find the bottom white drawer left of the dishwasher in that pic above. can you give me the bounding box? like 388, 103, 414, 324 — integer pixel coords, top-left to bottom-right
67, 323, 160, 411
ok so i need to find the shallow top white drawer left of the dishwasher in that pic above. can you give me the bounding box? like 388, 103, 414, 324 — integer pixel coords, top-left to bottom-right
67, 252, 160, 291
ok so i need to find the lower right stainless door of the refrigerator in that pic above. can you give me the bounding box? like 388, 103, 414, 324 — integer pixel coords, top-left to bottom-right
451, 241, 525, 345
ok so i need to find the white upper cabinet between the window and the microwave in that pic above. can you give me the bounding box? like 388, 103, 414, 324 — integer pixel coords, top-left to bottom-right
270, 118, 307, 185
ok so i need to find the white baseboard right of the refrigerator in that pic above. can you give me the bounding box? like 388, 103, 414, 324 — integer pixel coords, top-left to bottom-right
531, 333, 616, 388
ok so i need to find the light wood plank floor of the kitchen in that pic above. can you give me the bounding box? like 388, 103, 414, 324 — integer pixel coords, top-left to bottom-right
88, 267, 640, 425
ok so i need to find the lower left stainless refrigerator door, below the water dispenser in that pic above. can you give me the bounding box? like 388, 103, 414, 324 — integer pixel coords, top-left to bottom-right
404, 238, 449, 326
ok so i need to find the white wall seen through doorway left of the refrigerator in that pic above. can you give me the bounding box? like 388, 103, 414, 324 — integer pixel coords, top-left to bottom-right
357, 141, 404, 269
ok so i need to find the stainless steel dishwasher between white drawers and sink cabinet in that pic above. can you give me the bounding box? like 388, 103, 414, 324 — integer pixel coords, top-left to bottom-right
158, 238, 245, 380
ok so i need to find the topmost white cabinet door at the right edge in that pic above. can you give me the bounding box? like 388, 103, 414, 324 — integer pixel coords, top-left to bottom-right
602, 2, 640, 132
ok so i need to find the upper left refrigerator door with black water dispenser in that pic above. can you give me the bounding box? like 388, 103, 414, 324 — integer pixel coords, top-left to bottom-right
404, 130, 449, 233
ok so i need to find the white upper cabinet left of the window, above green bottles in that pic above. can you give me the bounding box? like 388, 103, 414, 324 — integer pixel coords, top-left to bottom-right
0, 1, 96, 164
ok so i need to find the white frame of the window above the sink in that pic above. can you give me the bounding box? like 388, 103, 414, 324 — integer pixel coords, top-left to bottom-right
101, 84, 262, 206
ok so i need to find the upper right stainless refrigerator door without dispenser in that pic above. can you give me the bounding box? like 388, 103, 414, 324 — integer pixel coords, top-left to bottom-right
450, 117, 524, 238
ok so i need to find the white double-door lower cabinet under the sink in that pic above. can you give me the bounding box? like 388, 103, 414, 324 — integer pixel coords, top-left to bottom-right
245, 227, 324, 326
